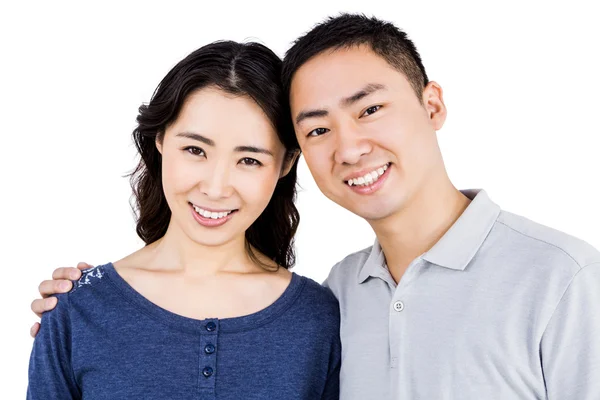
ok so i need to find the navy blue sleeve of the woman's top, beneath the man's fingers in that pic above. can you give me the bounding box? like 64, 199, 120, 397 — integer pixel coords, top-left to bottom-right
27, 295, 81, 400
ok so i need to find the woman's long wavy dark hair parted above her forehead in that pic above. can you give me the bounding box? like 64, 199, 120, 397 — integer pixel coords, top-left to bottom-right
130, 41, 300, 268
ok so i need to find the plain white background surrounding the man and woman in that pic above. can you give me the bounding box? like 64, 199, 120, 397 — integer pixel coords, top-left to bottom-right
0, 0, 600, 399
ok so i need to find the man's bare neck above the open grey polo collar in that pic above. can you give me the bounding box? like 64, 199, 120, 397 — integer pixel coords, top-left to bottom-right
370, 180, 470, 283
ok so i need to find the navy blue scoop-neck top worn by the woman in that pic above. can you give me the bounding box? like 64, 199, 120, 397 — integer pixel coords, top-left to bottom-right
27, 264, 340, 400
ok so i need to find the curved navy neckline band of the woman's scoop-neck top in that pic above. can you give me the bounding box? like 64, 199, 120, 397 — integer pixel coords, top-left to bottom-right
98, 262, 306, 333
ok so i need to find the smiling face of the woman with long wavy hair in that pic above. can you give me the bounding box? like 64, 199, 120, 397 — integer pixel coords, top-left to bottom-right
157, 87, 285, 246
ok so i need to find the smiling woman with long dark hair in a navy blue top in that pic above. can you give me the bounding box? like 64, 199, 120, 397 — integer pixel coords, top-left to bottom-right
28, 42, 340, 400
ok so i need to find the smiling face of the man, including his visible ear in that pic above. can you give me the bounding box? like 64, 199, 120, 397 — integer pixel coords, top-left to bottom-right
290, 46, 446, 221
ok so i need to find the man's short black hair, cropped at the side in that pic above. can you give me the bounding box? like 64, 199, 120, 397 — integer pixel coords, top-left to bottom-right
282, 13, 429, 101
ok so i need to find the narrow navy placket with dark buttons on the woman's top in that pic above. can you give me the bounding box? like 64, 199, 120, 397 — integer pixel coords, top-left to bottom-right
198, 319, 219, 398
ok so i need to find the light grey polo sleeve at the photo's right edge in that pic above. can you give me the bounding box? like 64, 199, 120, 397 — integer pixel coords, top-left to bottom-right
540, 263, 600, 400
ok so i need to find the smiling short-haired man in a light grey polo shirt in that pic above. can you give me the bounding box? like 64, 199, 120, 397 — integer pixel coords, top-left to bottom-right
34, 14, 600, 400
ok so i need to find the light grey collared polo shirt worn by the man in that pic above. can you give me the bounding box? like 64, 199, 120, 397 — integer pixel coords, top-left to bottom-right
325, 191, 600, 400
